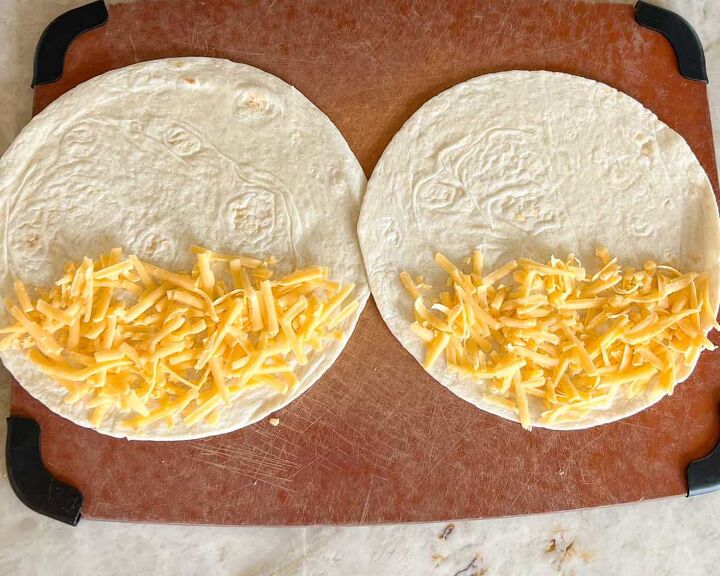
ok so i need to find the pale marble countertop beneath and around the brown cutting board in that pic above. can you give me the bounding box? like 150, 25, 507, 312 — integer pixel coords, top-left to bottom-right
0, 0, 720, 576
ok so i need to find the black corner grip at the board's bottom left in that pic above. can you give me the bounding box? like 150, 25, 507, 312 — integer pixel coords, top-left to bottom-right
5, 416, 83, 526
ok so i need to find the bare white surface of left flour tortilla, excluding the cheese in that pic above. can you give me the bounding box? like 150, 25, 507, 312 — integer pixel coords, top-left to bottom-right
0, 58, 369, 440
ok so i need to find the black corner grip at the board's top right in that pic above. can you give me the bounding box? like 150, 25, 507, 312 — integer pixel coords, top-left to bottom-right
635, 0, 708, 83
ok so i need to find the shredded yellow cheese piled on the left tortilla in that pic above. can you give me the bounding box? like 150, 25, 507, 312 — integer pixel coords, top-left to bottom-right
0, 247, 358, 429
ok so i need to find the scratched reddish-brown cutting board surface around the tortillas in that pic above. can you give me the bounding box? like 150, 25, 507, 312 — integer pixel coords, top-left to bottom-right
12, 0, 720, 524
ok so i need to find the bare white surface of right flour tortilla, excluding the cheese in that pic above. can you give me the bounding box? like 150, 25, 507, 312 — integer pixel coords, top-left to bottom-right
358, 71, 720, 429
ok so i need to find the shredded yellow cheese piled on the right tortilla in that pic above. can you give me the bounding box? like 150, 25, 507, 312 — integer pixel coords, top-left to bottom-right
400, 248, 718, 430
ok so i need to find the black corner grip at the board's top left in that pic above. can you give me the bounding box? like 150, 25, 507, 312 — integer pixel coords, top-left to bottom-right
32, 0, 108, 88
